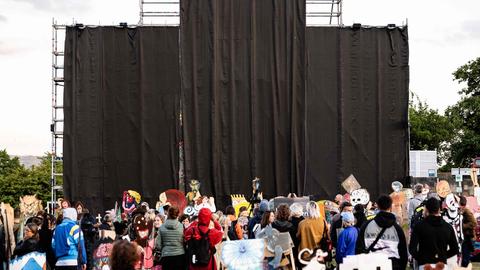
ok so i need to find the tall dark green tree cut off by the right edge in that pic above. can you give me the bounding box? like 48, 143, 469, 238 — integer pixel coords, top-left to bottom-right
445, 58, 480, 167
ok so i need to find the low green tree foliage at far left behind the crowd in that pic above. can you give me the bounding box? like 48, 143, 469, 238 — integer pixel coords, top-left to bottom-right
0, 150, 61, 207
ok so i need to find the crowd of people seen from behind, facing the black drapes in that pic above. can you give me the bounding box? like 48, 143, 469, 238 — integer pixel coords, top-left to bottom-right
1, 185, 477, 270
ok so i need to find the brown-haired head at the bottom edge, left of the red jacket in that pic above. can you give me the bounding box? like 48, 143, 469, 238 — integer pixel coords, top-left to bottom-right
109, 240, 140, 270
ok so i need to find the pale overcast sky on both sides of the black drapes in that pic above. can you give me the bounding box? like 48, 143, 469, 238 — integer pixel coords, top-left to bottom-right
0, 0, 480, 155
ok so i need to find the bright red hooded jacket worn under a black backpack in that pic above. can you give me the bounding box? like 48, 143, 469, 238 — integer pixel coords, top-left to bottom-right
184, 208, 223, 270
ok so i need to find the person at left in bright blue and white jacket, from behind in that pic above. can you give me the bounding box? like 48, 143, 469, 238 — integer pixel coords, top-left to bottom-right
52, 208, 87, 270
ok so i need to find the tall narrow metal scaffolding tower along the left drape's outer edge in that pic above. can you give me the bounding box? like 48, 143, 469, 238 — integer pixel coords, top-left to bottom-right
47, 19, 66, 213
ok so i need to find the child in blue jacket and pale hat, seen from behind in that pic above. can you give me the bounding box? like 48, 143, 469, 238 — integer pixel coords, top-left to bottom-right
336, 212, 358, 264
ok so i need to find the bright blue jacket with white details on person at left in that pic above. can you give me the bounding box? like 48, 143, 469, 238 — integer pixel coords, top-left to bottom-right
52, 219, 87, 266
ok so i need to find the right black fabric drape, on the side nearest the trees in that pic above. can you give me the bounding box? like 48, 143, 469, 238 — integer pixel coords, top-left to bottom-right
305, 28, 409, 199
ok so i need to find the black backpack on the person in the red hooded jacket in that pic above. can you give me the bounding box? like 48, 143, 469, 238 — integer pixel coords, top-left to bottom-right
187, 227, 214, 266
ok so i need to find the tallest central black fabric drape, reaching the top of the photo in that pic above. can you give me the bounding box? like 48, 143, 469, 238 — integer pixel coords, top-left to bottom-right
181, 0, 305, 209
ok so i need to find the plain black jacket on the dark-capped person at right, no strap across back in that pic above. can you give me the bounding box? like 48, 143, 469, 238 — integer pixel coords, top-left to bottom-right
408, 216, 459, 265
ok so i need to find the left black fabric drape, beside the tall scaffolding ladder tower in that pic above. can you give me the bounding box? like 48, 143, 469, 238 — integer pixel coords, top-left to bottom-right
64, 27, 180, 212
